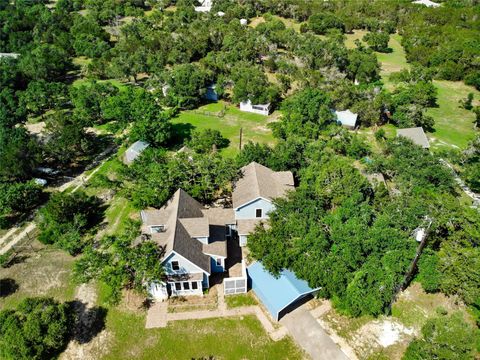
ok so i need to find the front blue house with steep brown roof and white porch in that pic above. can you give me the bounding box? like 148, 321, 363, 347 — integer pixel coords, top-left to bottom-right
141, 189, 235, 299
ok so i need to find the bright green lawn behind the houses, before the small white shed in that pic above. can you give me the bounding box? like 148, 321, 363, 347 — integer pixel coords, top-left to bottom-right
173, 103, 277, 156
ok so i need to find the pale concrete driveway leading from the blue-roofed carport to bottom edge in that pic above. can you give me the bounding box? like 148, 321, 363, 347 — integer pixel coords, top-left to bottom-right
280, 306, 348, 360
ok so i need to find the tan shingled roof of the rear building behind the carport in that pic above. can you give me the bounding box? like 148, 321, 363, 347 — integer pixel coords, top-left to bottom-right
233, 162, 294, 209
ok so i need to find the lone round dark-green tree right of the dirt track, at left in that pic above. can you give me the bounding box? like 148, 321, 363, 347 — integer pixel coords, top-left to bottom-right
37, 191, 102, 255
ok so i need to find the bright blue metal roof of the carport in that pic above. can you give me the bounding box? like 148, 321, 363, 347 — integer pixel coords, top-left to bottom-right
247, 261, 318, 320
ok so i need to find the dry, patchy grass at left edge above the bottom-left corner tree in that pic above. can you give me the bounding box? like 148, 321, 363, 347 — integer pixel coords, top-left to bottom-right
0, 241, 75, 310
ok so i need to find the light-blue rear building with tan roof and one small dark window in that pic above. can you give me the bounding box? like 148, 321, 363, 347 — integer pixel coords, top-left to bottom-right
232, 162, 295, 246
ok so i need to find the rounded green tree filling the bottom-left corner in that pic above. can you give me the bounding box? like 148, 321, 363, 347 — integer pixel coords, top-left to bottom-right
0, 298, 73, 360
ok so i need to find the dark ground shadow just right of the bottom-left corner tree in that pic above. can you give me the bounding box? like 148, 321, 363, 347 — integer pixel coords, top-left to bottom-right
69, 300, 107, 344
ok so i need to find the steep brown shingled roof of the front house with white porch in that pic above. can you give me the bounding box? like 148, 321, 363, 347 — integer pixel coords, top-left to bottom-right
142, 189, 210, 273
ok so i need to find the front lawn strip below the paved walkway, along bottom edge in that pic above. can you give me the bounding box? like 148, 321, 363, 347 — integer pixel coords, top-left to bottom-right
103, 309, 303, 360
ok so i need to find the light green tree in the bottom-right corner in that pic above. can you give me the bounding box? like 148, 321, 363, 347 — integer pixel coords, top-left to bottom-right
403, 313, 479, 360
